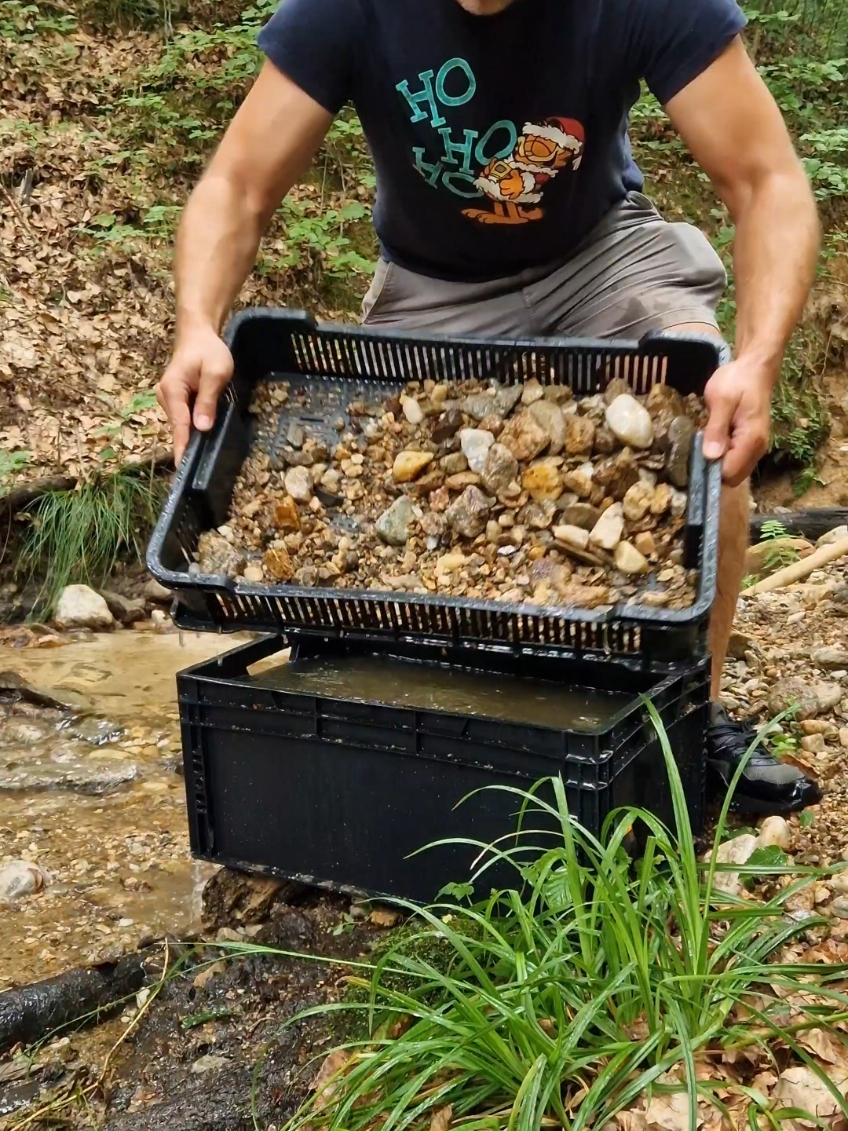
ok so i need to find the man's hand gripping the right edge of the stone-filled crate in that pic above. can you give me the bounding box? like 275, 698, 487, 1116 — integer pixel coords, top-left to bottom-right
703, 357, 775, 487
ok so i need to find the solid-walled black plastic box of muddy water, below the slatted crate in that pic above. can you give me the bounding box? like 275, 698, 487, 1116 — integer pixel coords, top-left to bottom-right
178, 637, 709, 900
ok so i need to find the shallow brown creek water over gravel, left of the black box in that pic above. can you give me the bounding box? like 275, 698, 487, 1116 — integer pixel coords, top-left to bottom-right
0, 631, 245, 990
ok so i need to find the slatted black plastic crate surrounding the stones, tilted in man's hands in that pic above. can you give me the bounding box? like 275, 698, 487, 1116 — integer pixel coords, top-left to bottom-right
147, 310, 728, 661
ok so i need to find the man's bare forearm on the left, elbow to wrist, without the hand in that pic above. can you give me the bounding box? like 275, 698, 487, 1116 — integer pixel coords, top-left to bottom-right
174, 173, 266, 338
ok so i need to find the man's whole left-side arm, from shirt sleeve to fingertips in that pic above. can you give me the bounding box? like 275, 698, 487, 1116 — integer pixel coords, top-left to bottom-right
157, 62, 332, 464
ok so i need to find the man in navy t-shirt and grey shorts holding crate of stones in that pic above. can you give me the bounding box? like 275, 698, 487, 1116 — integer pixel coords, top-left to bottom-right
159, 0, 820, 812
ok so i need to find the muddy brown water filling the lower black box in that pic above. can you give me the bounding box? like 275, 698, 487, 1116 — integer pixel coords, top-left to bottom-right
252, 656, 633, 732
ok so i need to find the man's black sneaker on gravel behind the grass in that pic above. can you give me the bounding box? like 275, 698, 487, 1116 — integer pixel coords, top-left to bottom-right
707, 703, 822, 814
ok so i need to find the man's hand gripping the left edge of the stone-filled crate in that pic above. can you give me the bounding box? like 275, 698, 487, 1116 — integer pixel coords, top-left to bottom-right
156, 326, 233, 467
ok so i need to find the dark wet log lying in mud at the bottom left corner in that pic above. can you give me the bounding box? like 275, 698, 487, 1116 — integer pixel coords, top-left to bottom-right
0, 953, 149, 1053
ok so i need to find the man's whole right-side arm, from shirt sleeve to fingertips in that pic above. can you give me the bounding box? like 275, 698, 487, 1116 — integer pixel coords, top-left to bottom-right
666, 38, 820, 485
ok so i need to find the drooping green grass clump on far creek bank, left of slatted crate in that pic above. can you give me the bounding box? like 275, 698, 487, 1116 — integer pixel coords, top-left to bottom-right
17, 469, 166, 616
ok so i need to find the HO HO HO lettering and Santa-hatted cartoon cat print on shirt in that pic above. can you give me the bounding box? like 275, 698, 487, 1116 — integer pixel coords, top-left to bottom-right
397, 58, 586, 224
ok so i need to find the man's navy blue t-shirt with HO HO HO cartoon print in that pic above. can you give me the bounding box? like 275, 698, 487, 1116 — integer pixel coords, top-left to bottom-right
259, 0, 745, 282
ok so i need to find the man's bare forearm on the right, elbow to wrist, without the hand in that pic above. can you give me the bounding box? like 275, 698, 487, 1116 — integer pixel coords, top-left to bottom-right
730, 166, 821, 381
